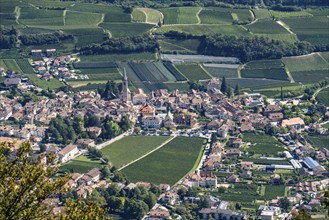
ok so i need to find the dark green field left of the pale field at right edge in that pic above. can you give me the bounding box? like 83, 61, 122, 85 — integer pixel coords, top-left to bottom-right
241, 60, 289, 80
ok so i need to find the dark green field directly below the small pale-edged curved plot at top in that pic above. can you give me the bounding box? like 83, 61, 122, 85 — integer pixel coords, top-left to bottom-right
100, 23, 153, 37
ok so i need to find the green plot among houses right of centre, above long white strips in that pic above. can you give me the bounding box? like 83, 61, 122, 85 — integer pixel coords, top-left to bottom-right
243, 133, 284, 156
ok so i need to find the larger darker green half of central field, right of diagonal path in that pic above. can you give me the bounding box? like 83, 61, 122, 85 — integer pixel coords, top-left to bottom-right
122, 137, 204, 185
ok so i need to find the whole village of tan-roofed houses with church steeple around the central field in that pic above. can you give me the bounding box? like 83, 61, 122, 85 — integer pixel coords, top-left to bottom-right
0, 51, 329, 220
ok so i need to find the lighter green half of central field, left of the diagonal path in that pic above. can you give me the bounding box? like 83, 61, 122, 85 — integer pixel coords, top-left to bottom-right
101, 136, 169, 168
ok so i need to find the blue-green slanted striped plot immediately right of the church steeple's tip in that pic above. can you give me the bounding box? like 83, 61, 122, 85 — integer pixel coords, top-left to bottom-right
129, 62, 168, 82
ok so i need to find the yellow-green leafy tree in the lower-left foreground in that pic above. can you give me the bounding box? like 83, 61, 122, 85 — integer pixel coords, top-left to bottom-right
0, 142, 104, 219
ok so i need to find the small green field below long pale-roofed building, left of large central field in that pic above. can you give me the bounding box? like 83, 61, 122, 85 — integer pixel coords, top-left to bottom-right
60, 155, 102, 173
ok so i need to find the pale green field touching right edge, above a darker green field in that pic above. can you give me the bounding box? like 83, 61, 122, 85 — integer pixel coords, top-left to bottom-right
282, 53, 329, 72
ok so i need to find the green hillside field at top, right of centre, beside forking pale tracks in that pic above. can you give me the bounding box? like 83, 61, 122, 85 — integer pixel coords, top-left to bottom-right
199, 8, 233, 24
